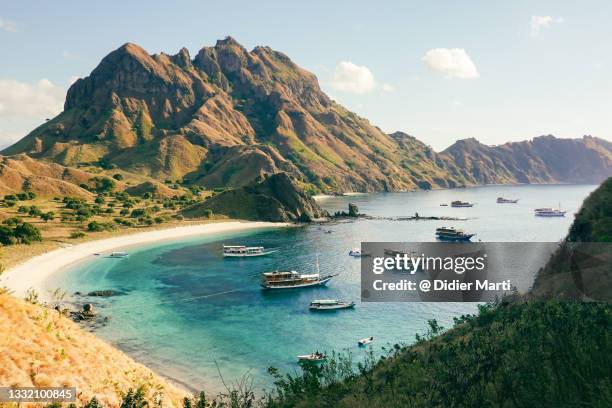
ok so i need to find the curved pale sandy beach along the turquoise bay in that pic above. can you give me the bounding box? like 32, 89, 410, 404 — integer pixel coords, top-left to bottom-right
0, 221, 289, 298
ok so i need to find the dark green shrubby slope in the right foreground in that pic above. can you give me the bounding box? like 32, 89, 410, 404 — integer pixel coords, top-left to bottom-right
268, 179, 612, 408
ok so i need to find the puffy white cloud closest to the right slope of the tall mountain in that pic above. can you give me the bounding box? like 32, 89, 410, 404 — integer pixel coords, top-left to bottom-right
331, 61, 394, 95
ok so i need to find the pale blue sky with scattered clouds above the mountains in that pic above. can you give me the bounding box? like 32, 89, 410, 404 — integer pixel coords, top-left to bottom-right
0, 0, 612, 150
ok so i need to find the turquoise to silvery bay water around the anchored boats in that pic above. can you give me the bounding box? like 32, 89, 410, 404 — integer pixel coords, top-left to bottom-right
53, 185, 595, 392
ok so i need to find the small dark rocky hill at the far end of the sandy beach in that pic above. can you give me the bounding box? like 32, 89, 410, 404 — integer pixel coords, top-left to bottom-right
182, 173, 328, 222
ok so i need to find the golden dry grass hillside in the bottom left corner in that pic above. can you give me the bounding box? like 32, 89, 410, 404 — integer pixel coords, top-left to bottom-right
0, 294, 185, 407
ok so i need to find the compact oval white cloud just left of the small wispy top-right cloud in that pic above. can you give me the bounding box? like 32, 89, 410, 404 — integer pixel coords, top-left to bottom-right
421, 48, 479, 79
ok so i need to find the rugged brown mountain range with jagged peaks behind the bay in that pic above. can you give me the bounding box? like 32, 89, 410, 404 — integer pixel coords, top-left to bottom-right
3, 37, 612, 196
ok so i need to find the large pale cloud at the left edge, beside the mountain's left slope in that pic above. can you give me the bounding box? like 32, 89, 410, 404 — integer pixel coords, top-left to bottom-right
0, 78, 66, 120
